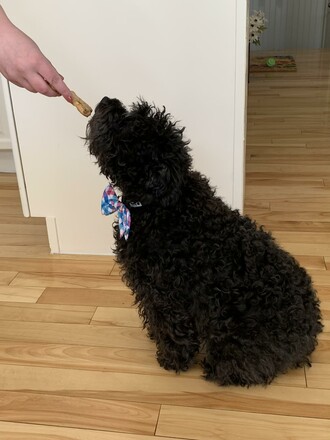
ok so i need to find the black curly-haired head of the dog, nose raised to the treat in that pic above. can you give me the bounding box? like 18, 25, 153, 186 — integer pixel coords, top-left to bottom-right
86, 97, 192, 206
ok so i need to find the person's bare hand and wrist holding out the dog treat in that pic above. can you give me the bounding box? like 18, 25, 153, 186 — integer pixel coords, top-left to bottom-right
0, 6, 72, 103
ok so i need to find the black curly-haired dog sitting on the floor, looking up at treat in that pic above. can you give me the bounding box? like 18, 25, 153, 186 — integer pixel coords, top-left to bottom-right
86, 97, 322, 386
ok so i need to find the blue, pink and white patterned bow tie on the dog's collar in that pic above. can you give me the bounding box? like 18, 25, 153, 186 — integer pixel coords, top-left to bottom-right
101, 185, 131, 240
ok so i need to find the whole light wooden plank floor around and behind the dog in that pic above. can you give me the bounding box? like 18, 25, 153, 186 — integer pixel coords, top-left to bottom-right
0, 51, 330, 440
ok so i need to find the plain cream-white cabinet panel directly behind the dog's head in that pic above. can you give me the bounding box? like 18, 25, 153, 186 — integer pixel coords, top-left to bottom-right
2, 0, 247, 254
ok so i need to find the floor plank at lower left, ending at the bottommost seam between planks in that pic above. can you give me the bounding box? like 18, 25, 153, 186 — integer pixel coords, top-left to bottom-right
0, 391, 160, 435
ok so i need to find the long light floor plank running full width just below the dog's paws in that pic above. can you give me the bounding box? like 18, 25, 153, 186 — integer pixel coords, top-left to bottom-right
0, 364, 314, 410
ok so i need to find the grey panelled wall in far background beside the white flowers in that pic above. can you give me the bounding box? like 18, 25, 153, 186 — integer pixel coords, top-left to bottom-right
250, 0, 328, 50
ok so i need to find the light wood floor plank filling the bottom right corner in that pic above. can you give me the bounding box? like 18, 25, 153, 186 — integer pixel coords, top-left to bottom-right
156, 406, 330, 440
